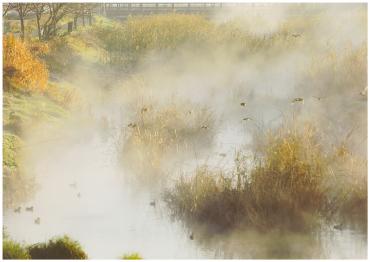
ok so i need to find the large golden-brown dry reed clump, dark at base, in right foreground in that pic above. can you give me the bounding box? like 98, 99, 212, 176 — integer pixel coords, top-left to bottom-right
165, 122, 367, 231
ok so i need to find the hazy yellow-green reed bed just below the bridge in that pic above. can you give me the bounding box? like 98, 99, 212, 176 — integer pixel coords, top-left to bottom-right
92, 14, 295, 69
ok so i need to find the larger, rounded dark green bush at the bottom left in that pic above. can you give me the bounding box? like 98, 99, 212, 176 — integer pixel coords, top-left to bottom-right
28, 236, 87, 259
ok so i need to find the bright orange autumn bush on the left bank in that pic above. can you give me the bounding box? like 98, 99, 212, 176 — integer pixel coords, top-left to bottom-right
3, 34, 48, 91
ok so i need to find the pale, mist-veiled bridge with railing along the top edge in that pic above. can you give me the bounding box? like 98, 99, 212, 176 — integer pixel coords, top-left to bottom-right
96, 3, 224, 19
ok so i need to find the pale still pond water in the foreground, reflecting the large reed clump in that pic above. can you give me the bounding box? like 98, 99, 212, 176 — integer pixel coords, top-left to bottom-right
4, 107, 367, 258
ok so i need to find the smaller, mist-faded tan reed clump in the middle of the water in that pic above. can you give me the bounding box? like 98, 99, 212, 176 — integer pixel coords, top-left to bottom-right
121, 103, 214, 185
